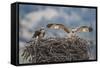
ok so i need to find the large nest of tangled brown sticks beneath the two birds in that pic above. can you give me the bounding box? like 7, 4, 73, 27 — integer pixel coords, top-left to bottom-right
22, 37, 89, 63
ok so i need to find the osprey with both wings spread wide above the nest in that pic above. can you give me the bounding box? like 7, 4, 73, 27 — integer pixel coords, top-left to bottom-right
47, 24, 93, 37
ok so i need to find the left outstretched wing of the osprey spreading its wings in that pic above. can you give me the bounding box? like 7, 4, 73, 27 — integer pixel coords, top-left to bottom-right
47, 24, 70, 33
